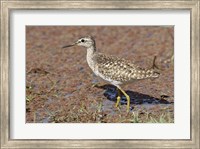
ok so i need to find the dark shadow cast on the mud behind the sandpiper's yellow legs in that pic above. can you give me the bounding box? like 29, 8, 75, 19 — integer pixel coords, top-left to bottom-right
96, 84, 173, 104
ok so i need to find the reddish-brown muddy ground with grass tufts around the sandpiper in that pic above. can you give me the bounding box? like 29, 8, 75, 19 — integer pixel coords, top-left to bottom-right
26, 26, 174, 123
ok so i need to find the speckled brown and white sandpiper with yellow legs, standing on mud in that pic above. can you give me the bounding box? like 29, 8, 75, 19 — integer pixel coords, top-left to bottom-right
63, 36, 159, 111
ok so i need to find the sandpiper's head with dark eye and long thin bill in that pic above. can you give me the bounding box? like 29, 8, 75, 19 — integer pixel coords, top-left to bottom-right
63, 36, 95, 48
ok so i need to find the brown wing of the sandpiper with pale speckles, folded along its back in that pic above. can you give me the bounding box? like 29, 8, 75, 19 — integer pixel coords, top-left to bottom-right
94, 53, 159, 82
